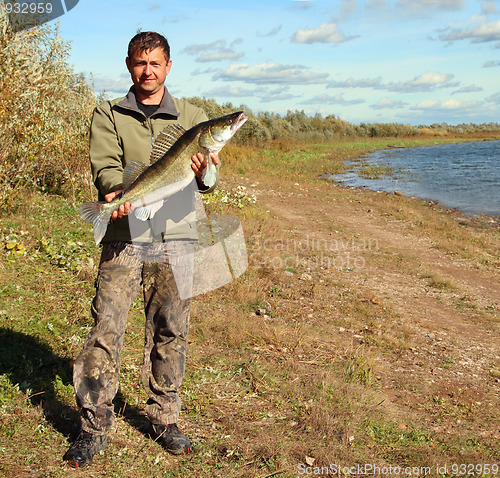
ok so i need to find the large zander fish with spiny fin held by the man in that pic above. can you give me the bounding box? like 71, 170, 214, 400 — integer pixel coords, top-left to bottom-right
80, 111, 248, 244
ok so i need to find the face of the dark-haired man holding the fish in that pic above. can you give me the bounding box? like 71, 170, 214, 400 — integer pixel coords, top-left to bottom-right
126, 48, 172, 100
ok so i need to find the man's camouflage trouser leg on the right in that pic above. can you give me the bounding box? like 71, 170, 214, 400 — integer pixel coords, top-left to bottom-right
142, 241, 193, 425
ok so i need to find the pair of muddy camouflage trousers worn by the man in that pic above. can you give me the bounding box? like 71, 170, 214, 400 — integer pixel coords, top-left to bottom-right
73, 240, 194, 434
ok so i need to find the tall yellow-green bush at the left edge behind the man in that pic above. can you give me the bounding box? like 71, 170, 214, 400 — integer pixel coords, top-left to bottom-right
0, 4, 96, 208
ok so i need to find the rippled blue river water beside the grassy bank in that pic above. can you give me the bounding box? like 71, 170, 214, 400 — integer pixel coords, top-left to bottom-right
330, 141, 500, 217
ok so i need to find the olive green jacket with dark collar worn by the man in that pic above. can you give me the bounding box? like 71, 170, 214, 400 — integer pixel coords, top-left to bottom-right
90, 87, 217, 242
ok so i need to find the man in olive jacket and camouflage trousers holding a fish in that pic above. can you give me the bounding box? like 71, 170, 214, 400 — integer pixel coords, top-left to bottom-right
64, 32, 219, 467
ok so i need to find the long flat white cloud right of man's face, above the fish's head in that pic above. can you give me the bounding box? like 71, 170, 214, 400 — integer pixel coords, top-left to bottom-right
214, 63, 328, 85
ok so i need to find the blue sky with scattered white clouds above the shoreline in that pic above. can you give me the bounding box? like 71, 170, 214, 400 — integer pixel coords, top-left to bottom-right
52, 0, 500, 125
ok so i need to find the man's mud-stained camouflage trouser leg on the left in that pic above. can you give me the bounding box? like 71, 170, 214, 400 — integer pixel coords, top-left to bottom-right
73, 242, 142, 435
